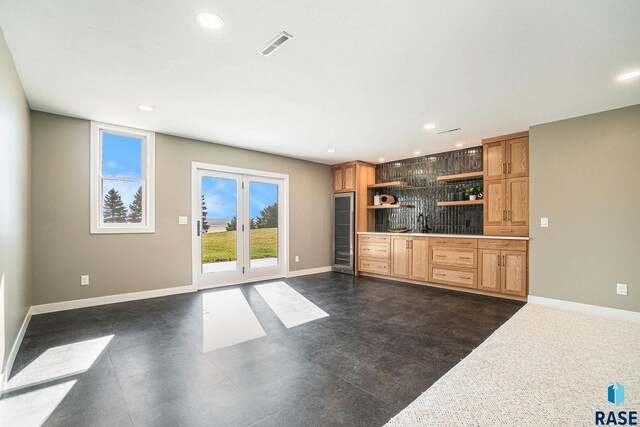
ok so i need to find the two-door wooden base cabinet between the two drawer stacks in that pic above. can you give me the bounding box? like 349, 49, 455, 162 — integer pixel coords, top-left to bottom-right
391, 236, 429, 281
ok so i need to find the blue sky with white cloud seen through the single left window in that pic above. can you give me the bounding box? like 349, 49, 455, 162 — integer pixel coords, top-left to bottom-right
102, 132, 142, 209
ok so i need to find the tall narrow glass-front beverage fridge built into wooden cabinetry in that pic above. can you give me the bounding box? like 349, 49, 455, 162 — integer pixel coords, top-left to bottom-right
333, 193, 355, 274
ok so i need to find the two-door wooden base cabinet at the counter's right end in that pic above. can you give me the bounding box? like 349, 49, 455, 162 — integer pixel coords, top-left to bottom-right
478, 244, 527, 296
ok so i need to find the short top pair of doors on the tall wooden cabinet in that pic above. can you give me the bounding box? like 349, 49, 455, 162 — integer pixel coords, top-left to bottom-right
482, 132, 529, 181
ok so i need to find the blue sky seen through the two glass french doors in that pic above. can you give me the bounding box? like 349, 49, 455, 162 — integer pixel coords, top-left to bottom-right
202, 177, 278, 219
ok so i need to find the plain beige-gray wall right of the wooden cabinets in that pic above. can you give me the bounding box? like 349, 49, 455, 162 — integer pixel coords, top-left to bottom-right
529, 105, 640, 311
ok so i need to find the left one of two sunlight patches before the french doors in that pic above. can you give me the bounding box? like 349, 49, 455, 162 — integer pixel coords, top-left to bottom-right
202, 289, 266, 353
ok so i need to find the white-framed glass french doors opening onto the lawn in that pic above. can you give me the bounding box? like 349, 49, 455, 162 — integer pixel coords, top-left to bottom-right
193, 166, 288, 289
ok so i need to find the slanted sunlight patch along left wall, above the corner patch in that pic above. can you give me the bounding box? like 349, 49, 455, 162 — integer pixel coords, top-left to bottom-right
6, 335, 113, 391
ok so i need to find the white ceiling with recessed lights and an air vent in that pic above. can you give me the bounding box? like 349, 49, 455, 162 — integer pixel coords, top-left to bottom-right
0, 0, 640, 164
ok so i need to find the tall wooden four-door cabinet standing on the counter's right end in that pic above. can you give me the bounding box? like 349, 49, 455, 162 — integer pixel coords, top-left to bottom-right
482, 132, 529, 236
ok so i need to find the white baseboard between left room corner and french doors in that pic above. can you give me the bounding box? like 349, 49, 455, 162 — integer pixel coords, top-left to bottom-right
31, 285, 197, 315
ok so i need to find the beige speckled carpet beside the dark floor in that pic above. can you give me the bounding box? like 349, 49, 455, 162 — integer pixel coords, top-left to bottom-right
387, 304, 640, 427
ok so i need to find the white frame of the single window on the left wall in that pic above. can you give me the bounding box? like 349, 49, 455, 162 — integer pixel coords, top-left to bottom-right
90, 121, 156, 234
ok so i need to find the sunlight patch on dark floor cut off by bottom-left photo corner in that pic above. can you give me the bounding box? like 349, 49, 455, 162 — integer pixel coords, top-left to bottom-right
0, 380, 76, 427
